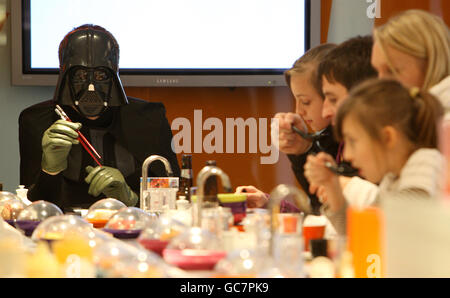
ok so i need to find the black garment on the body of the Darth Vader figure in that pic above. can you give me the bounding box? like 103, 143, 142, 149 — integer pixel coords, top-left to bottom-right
19, 97, 180, 212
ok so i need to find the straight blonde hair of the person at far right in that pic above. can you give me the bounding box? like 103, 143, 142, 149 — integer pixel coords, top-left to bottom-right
374, 9, 450, 90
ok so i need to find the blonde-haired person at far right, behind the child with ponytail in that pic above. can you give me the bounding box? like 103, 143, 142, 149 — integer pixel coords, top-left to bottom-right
372, 9, 450, 113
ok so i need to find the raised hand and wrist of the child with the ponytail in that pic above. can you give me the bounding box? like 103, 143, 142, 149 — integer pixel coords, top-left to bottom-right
304, 152, 345, 212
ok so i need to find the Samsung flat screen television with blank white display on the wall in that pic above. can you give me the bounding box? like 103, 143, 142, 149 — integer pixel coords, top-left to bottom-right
11, 0, 320, 87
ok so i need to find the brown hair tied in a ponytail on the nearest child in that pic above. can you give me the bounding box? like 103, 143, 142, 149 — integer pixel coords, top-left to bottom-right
335, 79, 443, 148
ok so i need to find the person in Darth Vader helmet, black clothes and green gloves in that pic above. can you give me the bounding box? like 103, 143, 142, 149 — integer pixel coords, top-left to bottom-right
19, 25, 180, 212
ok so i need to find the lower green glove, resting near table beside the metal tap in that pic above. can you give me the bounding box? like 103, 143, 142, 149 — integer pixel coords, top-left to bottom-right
84, 166, 138, 206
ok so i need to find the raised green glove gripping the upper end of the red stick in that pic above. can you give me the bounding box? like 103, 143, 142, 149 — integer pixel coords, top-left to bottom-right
41, 120, 81, 175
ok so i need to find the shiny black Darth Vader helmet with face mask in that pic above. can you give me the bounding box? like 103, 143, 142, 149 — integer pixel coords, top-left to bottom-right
55, 25, 128, 117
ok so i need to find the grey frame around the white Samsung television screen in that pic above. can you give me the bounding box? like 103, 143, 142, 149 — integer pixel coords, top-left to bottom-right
10, 0, 321, 87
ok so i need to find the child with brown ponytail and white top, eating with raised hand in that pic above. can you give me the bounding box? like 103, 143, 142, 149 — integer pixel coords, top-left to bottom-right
305, 80, 443, 234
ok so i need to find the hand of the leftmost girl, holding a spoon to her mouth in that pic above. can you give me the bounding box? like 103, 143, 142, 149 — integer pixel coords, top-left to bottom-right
271, 113, 311, 155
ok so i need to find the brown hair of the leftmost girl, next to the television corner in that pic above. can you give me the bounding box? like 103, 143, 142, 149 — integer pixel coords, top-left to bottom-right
284, 43, 336, 98
